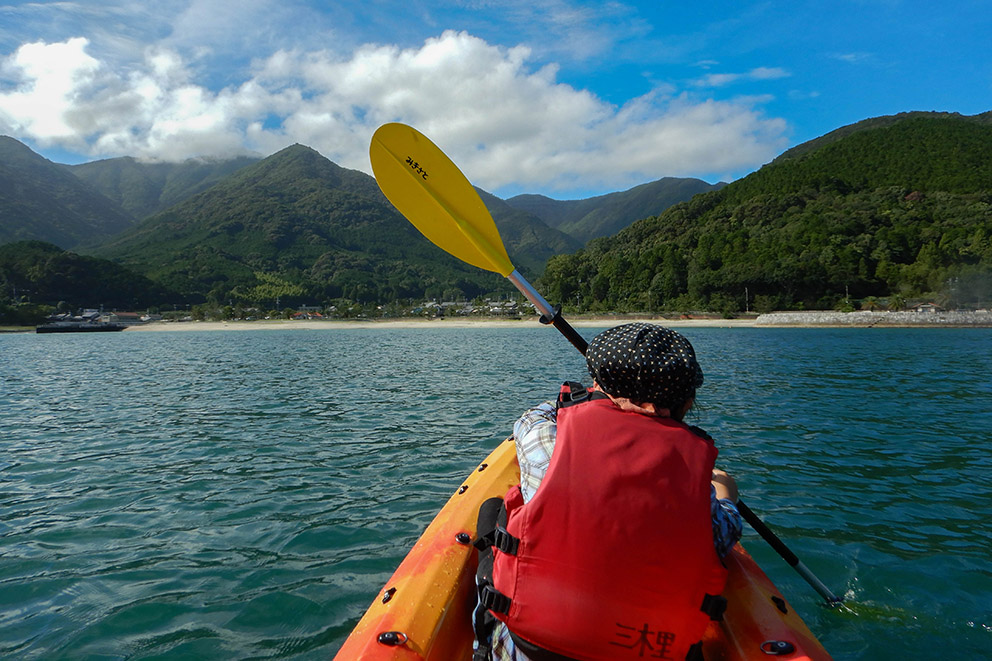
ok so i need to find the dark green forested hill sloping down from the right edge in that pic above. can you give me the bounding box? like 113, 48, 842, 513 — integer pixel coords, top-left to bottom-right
542, 113, 992, 312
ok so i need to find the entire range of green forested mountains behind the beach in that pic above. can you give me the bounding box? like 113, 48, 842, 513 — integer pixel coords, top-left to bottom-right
0, 113, 992, 314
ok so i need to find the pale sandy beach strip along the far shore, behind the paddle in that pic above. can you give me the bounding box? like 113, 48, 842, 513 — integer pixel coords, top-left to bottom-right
125, 316, 755, 333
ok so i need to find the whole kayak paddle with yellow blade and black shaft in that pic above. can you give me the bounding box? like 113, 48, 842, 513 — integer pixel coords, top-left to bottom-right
369, 124, 842, 605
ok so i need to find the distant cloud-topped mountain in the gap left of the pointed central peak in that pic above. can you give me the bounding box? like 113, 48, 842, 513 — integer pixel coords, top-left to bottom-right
72, 157, 259, 219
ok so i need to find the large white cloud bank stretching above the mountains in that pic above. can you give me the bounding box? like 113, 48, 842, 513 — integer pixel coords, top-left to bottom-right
0, 31, 788, 190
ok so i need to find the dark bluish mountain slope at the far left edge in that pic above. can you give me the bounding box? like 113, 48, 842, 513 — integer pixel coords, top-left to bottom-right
0, 136, 133, 248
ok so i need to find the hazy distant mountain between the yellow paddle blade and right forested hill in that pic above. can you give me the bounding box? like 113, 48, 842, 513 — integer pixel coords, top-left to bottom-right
506, 177, 726, 243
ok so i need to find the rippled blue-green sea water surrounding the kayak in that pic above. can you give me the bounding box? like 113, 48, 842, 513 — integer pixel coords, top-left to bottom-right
0, 323, 992, 661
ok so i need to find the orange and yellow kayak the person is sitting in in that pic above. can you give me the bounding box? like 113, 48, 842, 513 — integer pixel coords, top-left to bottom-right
335, 438, 830, 661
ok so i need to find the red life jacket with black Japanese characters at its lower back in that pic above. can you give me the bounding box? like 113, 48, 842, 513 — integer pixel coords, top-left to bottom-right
493, 384, 727, 661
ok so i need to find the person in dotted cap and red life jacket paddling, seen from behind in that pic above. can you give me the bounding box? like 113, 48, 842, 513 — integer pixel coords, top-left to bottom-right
475, 323, 741, 661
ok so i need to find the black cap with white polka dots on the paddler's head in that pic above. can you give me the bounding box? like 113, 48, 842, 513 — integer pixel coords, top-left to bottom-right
586, 323, 703, 409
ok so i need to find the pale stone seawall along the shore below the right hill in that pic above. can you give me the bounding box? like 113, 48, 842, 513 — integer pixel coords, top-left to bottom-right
754, 310, 992, 328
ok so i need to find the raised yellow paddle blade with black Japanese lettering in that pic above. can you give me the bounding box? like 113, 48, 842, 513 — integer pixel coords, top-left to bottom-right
369, 124, 513, 277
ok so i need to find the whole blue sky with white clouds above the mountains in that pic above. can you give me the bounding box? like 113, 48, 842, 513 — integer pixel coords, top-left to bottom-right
0, 0, 992, 199
